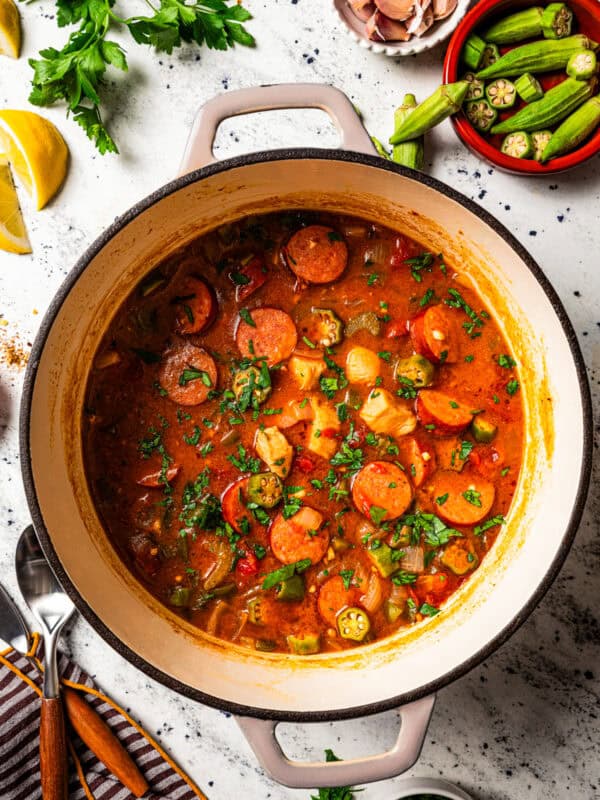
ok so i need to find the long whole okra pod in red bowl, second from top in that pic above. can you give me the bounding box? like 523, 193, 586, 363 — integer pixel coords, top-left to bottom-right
476, 34, 598, 78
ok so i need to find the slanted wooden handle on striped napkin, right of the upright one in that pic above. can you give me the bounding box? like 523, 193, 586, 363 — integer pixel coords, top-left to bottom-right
63, 687, 149, 800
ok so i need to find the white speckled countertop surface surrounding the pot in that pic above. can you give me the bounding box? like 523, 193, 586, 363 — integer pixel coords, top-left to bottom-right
0, 0, 600, 800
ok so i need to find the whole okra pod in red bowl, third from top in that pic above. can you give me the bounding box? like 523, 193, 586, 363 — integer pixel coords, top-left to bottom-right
492, 78, 593, 133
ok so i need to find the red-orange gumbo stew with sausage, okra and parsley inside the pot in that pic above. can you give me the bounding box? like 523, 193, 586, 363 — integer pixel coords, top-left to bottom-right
84, 212, 523, 655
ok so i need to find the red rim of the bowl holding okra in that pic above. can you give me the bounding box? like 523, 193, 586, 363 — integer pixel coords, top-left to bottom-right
442, 0, 600, 176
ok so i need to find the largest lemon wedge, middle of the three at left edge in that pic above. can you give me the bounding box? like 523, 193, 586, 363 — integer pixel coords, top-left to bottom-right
0, 110, 69, 211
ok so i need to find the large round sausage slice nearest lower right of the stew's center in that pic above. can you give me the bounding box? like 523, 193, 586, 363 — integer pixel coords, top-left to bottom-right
352, 461, 413, 522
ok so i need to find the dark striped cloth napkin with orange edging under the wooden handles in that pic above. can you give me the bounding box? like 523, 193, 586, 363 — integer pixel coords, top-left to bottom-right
0, 634, 206, 800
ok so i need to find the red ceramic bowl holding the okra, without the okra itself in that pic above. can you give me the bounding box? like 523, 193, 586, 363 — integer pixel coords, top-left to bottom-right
444, 0, 600, 175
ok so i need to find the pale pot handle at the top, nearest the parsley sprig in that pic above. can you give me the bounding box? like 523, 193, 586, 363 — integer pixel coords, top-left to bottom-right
179, 83, 375, 175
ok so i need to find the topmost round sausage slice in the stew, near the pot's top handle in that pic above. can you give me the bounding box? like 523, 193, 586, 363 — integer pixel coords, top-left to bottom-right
285, 225, 348, 283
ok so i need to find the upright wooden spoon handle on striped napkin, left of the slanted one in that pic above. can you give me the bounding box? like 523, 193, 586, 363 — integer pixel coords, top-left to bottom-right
40, 697, 68, 800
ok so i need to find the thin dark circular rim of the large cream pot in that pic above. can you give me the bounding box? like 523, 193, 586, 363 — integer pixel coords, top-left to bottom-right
19, 148, 592, 722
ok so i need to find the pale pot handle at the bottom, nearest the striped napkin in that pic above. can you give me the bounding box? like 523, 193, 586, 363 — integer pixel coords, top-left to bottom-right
236, 695, 435, 789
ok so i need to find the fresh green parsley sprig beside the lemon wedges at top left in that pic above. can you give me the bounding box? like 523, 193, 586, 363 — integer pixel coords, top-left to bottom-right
29, 0, 255, 154
